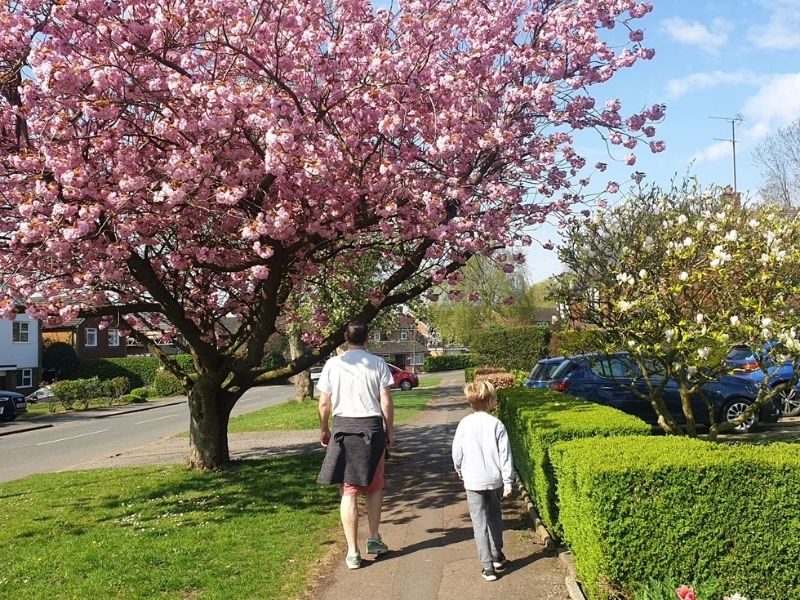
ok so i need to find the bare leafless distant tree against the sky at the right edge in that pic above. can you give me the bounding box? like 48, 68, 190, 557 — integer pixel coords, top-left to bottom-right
754, 118, 800, 206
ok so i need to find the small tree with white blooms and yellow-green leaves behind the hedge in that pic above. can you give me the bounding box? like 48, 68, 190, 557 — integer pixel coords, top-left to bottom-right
558, 182, 800, 438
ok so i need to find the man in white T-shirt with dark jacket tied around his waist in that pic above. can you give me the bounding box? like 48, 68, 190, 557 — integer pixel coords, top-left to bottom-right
317, 318, 394, 569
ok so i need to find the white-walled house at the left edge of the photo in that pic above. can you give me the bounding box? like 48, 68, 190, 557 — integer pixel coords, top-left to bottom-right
0, 315, 42, 395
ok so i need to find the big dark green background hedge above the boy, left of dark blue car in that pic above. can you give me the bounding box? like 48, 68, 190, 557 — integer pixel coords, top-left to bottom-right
472, 325, 550, 371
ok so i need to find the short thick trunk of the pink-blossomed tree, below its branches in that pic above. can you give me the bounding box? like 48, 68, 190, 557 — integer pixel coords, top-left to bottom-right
189, 375, 231, 470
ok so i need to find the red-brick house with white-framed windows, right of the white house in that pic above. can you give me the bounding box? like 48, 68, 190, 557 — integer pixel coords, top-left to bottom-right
42, 317, 128, 360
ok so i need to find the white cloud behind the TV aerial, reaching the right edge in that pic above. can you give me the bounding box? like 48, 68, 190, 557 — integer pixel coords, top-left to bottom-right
694, 73, 800, 163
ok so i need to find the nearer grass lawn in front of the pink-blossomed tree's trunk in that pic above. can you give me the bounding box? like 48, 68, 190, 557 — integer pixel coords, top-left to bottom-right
0, 453, 339, 600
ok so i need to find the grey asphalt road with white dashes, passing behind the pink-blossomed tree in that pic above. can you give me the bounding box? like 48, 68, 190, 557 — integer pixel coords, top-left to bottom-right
0, 385, 293, 482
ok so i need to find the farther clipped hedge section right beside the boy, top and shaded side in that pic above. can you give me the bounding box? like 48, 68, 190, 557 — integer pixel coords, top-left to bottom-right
498, 389, 651, 535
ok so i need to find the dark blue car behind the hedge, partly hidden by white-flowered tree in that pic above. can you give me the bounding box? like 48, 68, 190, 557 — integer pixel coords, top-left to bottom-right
551, 353, 781, 433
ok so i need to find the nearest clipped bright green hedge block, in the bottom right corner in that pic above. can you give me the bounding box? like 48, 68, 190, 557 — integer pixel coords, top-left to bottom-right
551, 437, 800, 600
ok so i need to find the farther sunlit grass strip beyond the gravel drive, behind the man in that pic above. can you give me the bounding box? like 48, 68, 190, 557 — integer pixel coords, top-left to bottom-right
228, 389, 433, 433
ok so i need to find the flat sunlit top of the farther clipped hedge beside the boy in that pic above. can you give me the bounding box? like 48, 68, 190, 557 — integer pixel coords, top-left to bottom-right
499, 389, 651, 443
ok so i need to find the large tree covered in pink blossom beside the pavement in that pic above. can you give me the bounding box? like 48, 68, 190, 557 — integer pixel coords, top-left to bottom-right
0, 0, 663, 468
